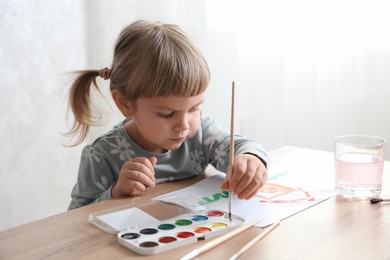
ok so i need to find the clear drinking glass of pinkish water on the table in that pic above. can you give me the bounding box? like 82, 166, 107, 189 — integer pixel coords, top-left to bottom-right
334, 135, 386, 199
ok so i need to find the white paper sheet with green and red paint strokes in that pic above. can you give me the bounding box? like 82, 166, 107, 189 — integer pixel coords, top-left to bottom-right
154, 173, 334, 227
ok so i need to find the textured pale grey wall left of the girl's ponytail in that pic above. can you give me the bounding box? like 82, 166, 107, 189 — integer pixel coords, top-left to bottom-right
0, 0, 86, 230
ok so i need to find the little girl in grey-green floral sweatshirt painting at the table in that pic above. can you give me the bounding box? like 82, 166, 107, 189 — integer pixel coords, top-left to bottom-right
69, 21, 268, 210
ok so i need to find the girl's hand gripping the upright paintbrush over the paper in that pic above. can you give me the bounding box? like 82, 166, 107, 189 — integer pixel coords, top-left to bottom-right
221, 154, 268, 200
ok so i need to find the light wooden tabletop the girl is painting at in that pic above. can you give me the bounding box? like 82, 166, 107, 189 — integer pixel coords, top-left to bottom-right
0, 147, 390, 260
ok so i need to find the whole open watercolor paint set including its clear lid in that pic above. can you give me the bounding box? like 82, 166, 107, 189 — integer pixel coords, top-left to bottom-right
89, 202, 245, 255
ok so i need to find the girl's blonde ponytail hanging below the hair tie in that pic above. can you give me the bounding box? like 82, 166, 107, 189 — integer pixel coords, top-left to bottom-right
66, 70, 101, 146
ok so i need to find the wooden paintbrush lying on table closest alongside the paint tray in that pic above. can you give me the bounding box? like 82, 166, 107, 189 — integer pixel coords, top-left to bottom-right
180, 218, 261, 260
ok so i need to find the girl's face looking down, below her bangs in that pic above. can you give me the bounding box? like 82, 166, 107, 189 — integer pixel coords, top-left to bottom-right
125, 93, 204, 153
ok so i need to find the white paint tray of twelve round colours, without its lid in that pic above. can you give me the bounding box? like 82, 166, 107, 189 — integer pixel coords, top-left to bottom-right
117, 210, 245, 255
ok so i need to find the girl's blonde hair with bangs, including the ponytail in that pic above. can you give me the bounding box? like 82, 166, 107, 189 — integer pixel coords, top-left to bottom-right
67, 20, 210, 145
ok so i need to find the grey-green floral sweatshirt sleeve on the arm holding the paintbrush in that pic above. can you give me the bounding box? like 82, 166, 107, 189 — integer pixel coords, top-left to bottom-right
201, 116, 268, 172
